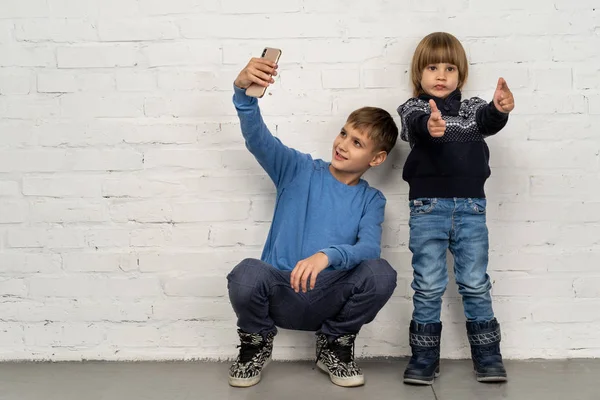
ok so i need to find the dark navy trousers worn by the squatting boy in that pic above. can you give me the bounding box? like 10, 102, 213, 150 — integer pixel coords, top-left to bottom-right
227, 258, 396, 340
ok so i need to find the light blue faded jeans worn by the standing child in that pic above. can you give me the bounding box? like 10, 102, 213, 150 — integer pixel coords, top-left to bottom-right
409, 198, 494, 324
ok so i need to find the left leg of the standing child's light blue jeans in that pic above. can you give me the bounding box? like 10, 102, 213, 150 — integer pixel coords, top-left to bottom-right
409, 199, 454, 324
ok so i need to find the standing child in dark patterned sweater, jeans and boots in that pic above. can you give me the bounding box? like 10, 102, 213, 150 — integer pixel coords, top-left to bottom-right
398, 32, 514, 384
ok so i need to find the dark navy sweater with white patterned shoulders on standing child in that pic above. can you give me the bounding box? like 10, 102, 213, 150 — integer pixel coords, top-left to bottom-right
398, 89, 508, 200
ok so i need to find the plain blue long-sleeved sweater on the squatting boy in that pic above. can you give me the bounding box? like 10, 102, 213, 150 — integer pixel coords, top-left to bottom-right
233, 87, 386, 270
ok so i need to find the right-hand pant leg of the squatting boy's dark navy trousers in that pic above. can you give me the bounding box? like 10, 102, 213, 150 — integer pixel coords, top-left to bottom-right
314, 259, 397, 339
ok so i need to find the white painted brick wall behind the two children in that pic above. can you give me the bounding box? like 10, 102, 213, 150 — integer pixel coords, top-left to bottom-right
0, 0, 600, 360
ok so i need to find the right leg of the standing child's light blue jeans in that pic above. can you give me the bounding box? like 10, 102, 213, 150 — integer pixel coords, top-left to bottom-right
450, 199, 494, 322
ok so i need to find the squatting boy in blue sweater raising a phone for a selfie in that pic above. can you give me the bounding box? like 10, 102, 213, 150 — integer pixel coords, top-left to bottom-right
227, 58, 398, 387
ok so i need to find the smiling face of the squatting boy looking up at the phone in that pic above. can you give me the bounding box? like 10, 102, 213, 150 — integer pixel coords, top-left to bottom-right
331, 123, 380, 173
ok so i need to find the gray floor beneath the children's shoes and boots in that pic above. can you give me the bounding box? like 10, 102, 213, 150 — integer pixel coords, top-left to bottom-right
0, 360, 600, 400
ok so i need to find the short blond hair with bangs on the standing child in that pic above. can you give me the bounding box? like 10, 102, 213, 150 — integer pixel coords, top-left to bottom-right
410, 32, 469, 97
